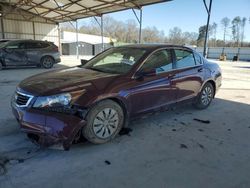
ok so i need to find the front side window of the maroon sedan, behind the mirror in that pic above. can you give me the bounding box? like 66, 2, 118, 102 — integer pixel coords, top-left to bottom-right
141, 50, 173, 74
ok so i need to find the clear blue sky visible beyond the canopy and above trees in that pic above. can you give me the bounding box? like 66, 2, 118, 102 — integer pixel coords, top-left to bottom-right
78, 0, 250, 42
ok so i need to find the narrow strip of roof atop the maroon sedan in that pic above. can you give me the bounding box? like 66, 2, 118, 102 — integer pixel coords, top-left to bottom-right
118, 44, 193, 51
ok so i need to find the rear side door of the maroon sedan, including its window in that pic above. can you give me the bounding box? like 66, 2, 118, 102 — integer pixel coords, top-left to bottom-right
172, 48, 204, 101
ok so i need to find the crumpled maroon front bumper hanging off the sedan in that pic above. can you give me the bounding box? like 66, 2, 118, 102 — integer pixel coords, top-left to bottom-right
11, 103, 86, 150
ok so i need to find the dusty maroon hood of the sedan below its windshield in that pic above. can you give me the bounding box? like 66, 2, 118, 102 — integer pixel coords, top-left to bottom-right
18, 67, 118, 96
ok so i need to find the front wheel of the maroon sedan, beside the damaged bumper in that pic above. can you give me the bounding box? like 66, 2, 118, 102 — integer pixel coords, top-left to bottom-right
82, 100, 124, 144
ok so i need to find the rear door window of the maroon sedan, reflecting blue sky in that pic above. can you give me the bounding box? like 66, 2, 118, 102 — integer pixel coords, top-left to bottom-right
174, 49, 196, 69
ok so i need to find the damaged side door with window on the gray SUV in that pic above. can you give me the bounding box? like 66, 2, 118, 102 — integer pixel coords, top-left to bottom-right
3, 41, 27, 66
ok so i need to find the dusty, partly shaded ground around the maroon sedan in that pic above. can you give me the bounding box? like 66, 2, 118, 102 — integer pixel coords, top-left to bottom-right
0, 58, 250, 188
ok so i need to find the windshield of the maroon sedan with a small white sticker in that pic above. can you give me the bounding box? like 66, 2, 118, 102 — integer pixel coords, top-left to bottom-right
83, 47, 146, 74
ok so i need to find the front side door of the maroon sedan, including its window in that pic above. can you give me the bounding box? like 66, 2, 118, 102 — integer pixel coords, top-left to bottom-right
127, 49, 176, 115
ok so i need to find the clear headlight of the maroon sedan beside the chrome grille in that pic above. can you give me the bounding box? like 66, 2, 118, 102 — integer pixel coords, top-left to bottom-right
33, 93, 72, 108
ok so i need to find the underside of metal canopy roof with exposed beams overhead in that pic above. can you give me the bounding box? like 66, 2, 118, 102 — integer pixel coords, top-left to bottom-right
2, 0, 171, 23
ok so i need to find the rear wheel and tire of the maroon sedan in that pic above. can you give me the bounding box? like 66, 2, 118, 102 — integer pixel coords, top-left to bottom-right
194, 82, 215, 109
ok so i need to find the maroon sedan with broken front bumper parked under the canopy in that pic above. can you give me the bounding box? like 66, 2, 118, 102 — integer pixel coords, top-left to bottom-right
12, 45, 221, 149
